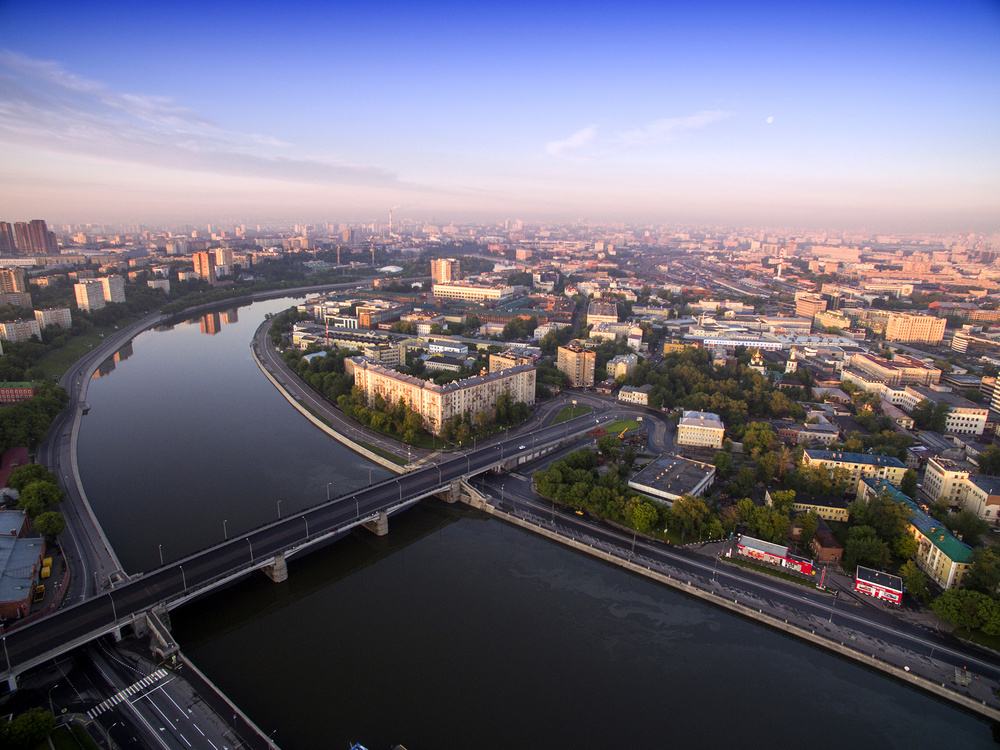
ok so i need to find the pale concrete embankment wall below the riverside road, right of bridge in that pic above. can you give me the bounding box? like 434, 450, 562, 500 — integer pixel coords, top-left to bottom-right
469, 493, 1000, 722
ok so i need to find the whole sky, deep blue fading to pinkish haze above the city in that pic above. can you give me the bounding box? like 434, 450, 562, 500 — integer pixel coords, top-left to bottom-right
0, 0, 1000, 231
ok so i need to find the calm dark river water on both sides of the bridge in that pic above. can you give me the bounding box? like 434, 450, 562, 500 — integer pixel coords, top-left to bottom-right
80, 300, 995, 750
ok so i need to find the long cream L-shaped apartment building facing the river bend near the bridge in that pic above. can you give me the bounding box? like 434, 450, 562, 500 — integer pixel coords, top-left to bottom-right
352, 357, 535, 435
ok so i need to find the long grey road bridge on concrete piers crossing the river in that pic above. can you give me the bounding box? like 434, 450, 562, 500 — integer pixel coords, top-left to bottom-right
0, 416, 594, 689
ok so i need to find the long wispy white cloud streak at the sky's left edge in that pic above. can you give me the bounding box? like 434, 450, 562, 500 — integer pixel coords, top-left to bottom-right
0, 50, 416, 188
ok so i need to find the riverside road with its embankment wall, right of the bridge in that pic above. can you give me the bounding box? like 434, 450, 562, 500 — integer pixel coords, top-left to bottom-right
468, 486, 1000, 723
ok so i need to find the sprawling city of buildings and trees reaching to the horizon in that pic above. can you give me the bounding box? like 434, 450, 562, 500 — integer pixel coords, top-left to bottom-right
0, 214, 1000, 747
